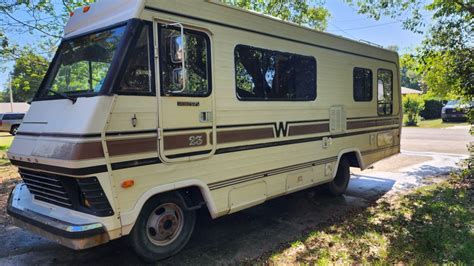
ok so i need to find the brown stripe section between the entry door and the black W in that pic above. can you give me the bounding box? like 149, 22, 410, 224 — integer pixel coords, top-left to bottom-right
215, 128, 274, 144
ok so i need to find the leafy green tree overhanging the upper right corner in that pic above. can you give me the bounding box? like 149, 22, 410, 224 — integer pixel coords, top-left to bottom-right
346, 0, 474, 100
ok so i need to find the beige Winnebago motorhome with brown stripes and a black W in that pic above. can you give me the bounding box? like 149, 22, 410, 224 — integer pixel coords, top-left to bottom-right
8, 0, 402, 261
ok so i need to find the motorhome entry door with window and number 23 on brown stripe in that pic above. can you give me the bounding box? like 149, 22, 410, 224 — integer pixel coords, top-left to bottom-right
154, 21, 216, 162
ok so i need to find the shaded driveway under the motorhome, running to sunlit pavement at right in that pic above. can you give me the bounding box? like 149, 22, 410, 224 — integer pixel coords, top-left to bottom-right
0, 125, 474, 265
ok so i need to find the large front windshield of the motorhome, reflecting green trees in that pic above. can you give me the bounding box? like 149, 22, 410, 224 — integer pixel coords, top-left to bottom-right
41, 26, 125, 97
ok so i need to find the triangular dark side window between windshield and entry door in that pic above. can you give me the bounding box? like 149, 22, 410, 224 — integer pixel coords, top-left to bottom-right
116, 25, 152, 94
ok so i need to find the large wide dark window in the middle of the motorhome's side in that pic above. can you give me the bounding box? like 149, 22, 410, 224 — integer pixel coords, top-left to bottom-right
234, 45, 316, 101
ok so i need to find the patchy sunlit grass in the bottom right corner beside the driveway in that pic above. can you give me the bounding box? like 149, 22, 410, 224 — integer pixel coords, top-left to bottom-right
265, 177, 474, 265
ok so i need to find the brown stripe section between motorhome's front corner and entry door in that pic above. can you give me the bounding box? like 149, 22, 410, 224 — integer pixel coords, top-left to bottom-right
107, 137, 158, 156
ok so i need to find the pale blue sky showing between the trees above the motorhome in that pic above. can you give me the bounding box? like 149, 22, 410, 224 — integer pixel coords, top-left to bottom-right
0, 0, 430, 93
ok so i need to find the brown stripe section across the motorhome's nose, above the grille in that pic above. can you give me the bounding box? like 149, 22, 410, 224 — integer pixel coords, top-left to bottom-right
31, 142, 104, 160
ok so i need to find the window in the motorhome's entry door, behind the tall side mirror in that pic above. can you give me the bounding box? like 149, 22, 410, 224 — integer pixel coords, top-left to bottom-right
160, 25, 211, 97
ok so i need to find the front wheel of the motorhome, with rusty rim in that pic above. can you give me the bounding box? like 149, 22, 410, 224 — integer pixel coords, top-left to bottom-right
130, 194, 196, 262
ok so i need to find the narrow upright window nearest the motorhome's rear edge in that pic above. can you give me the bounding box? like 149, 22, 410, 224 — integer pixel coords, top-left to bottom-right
377, 69, 393, 115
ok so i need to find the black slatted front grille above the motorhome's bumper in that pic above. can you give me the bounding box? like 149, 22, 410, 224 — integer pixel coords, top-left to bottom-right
20, 169, 114, 217
